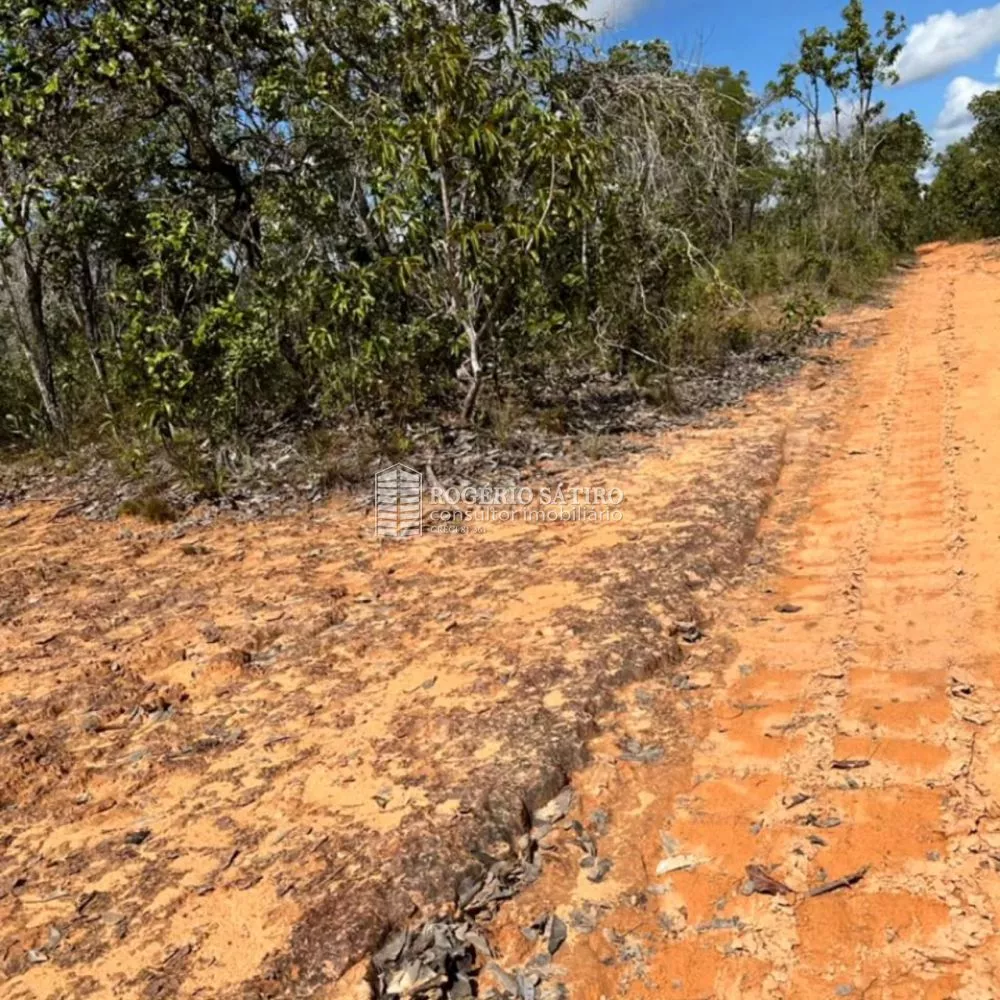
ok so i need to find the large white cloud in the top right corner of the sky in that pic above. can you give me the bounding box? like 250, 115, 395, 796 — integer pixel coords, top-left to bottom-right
896, 3, 1000, 83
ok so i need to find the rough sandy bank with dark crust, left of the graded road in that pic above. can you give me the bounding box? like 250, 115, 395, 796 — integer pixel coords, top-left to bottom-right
0, 338, 785, 1000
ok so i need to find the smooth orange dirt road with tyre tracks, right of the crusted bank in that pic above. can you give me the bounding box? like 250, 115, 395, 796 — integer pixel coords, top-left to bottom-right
482, 246, 1000, 1000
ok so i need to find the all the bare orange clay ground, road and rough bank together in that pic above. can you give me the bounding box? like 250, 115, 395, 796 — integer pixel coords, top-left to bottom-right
0, 246, 1000, 1000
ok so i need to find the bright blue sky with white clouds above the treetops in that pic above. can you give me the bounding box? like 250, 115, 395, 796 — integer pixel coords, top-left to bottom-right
589, 0, 1000, 149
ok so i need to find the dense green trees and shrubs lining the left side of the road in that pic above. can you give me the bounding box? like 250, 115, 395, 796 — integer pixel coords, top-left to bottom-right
0, 0, 928, 460
